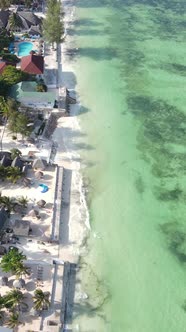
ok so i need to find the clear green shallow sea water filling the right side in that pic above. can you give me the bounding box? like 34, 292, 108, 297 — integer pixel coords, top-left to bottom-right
68, 0, 186, 332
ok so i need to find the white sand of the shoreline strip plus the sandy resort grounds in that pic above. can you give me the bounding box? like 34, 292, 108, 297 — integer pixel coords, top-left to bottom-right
1, 1, 89, 331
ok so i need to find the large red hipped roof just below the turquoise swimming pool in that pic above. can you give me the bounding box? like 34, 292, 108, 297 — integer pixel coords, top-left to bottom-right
21, 54, 44, 75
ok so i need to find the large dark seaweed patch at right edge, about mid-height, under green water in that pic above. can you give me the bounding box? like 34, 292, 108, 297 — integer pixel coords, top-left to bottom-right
128, 96, 186, 182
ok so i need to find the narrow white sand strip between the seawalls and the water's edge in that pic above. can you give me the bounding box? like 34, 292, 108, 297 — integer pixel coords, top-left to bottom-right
51, 1, 89, 263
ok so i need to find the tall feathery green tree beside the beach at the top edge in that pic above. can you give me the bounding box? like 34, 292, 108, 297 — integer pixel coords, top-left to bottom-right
42, 0, 64, 45
